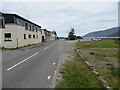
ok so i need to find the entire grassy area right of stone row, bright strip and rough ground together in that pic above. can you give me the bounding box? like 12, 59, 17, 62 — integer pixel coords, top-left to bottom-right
76, 40, 120, 89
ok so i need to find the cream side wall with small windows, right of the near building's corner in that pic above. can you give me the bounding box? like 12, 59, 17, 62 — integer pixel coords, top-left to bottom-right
17, 26, 42, 47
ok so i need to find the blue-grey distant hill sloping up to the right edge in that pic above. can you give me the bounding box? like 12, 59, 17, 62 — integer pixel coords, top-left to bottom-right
83, 27, 120, 38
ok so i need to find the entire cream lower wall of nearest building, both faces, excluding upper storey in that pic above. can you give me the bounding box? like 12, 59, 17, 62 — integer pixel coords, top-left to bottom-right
1, 24, 42, 48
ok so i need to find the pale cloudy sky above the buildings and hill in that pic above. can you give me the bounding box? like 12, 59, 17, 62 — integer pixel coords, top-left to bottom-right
1, 0, 118, 36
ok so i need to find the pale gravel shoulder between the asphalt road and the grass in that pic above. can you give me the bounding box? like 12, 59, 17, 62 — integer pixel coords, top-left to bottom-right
50, 40, 77, 88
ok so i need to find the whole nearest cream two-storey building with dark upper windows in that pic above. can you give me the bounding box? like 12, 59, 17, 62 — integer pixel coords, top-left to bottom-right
0, 13, 57, 48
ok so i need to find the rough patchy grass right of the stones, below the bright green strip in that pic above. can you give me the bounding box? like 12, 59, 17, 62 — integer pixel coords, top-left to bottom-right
80, 48, 120, 88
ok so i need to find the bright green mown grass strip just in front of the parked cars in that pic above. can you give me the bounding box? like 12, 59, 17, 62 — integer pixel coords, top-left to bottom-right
76, 40, 119, 48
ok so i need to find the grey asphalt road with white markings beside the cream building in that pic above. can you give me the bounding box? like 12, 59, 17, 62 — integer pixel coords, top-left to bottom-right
2, 40, 64, 88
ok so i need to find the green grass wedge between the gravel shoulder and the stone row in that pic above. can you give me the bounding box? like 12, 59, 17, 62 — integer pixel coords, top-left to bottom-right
56, 56, 103, 88
